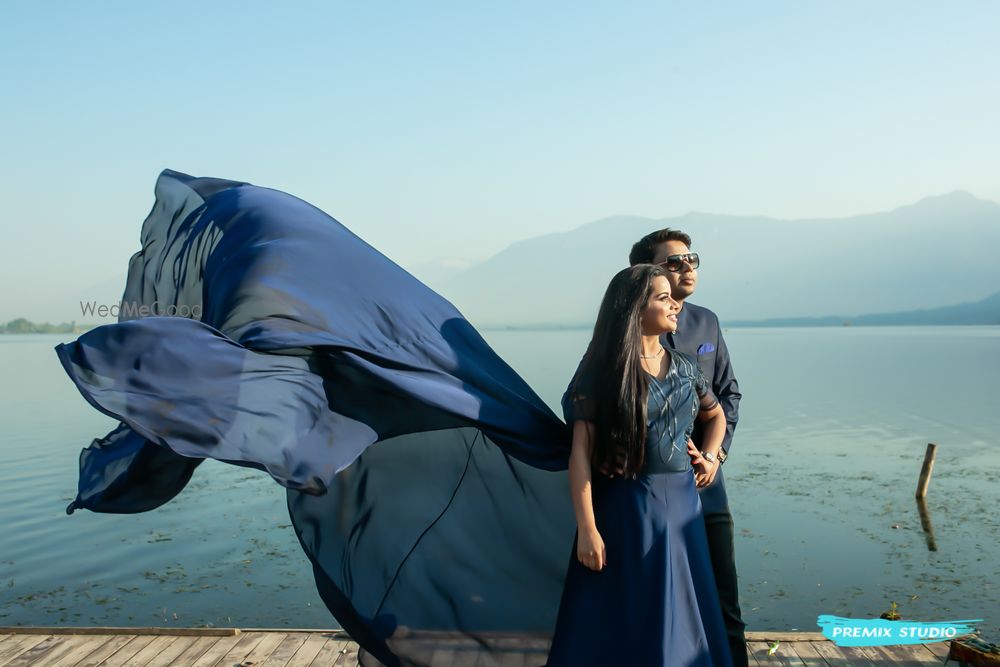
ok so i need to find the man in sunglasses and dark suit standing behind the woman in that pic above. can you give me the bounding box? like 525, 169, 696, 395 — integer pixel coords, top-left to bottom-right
629, 229, 748, 667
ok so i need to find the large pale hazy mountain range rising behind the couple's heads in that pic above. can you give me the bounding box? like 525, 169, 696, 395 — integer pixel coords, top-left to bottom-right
432, 191, 1000, 326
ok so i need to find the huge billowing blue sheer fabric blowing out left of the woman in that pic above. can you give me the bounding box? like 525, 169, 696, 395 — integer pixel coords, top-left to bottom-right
56, 171, 575, 665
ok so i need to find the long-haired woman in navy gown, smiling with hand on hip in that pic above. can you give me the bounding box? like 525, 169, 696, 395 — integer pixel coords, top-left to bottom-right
548, 264, 731, 667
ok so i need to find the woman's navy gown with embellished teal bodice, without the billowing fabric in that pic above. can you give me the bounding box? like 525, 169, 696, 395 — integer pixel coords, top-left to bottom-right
548, 352, 732, 667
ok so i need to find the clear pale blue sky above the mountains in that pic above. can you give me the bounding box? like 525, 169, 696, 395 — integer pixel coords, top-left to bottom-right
0, 0, 1000, 319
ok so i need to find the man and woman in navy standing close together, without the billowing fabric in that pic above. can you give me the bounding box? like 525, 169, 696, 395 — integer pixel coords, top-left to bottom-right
548, 229, 747, 667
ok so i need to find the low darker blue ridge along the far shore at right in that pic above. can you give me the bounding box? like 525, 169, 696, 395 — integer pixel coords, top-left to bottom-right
724, 292, 1000, 327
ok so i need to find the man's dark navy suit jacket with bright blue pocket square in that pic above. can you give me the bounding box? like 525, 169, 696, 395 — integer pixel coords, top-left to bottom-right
663, 302, 742, 514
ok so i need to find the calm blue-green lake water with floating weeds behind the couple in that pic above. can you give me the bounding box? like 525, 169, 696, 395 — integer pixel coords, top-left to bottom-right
0, 327, 1000, 640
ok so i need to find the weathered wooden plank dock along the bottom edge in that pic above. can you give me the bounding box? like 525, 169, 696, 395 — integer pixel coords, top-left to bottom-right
0, 628, 955, 667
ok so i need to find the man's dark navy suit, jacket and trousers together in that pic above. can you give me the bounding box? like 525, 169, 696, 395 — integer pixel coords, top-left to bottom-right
663, 302, 747, 667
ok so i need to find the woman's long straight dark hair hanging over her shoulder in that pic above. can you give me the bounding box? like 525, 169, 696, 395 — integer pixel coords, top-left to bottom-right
574, 264, 666, 476
